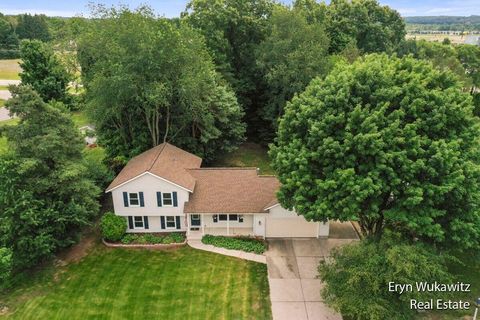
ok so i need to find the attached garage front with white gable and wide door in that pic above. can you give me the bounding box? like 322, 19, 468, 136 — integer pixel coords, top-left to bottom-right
265, 205, 328, 238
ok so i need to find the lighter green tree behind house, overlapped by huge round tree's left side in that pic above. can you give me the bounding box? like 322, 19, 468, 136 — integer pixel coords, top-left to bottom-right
257, 6, 331, 141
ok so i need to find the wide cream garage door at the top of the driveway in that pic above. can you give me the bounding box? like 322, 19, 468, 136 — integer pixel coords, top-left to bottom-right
265, 217, 318, 238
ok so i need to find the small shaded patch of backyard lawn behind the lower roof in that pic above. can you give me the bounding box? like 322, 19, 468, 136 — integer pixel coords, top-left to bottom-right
212, 142, 274, 174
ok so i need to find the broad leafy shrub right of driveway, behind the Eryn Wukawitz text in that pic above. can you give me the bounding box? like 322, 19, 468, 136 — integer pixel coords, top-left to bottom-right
319, 240, 454, 320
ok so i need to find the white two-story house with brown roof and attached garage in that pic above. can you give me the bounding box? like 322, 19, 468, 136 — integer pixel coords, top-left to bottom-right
106, 143, 329, 238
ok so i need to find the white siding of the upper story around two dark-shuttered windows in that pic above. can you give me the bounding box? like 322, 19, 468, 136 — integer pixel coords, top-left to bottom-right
112, 174, 189, 216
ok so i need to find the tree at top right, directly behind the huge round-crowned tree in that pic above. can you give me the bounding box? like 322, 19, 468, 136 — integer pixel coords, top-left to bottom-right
325, 0, 406, 53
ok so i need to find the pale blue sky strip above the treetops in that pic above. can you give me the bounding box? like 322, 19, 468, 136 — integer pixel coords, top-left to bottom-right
0, 0, 480, 18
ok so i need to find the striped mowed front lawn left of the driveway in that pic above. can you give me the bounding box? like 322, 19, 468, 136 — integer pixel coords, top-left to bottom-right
0, 246, 271, 320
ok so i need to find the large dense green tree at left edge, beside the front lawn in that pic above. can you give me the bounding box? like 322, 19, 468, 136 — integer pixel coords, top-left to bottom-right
0, 85, 99, 270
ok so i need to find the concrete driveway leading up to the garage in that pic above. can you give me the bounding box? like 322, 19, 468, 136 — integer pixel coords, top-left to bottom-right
266, 223, 358, 320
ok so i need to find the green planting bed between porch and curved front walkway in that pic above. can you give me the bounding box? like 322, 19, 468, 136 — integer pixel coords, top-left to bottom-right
202, 234, 268, 254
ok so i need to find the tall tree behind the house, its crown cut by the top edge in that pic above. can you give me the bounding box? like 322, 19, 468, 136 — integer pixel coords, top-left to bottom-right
182, 0, 274, 134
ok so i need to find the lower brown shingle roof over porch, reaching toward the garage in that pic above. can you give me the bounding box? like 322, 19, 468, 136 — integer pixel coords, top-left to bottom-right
184, 168, 280, 213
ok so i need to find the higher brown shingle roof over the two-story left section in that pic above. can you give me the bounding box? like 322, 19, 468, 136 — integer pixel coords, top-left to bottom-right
107, 143, 202, 192
